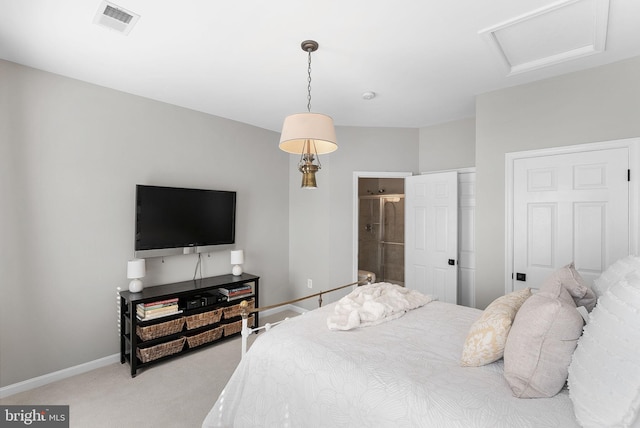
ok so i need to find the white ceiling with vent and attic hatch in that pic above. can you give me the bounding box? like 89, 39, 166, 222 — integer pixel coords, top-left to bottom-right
0, 0, 640, 131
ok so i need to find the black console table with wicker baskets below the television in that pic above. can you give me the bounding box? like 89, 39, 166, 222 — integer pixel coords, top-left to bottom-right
120, 273, 260, 377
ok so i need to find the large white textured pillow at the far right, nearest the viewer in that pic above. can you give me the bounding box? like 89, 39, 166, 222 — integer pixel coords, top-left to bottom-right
569, 271, 640, 427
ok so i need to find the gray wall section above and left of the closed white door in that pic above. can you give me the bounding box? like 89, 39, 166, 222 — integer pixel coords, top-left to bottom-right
476, 57, 640, 308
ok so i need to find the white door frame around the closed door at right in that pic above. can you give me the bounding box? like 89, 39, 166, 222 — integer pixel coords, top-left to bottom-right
504, 138, 640, 294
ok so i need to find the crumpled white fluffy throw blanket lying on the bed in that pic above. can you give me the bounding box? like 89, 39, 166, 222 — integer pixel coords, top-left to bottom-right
327, 282, 433, 330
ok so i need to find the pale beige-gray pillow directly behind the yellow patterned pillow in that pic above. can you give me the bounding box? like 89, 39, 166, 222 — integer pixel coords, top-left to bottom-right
504, 279, 584, 398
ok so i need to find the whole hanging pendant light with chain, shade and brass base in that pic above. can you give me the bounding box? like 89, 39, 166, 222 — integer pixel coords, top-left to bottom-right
280, 40, 338, 189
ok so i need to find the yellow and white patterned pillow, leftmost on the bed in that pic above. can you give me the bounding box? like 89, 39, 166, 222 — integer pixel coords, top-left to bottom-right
460, 288, 531, 367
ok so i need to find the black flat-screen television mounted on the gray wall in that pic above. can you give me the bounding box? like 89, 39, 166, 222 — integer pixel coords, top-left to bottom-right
134, 184, 236, 257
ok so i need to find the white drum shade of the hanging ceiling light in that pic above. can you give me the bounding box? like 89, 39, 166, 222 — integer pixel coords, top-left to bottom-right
280, 113, 338, 155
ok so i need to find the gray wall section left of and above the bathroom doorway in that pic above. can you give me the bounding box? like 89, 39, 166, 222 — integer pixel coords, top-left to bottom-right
289, 127, 418, 308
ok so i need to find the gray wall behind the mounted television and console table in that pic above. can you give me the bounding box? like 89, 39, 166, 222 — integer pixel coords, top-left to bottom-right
0, 61, 289, 386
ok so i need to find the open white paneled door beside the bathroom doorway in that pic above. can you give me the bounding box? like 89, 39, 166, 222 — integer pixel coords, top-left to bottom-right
405, 171, 458, 303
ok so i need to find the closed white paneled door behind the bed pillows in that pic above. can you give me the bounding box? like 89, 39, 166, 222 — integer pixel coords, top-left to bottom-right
512, 148, 629, 290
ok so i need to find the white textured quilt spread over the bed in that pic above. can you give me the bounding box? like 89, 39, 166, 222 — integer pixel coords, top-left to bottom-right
203, 301, 578, 428
